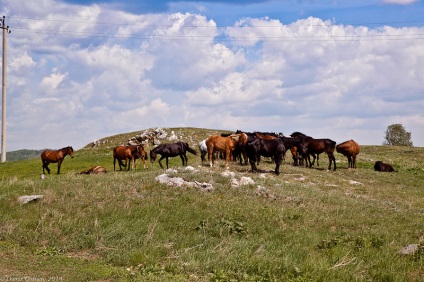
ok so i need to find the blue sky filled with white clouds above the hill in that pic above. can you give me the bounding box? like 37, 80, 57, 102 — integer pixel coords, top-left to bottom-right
0, 0, 424, 151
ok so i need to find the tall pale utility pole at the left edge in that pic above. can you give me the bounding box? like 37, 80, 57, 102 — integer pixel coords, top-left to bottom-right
0, 16, 10, 163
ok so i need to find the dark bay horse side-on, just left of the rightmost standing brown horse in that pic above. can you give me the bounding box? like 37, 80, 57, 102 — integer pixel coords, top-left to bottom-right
290, 132, 336, 170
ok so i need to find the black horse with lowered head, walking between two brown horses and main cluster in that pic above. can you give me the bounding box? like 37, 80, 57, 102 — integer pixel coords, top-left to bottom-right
150, 141, 197, 169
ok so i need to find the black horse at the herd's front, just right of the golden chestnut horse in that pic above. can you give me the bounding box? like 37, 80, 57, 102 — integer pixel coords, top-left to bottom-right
245, 138, 286, 175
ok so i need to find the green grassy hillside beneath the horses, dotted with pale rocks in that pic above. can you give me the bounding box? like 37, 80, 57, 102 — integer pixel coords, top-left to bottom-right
0, 128, 424, 281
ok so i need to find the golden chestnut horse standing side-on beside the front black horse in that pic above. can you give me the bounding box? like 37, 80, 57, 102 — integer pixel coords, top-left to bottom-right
206, 133, 247, 169
